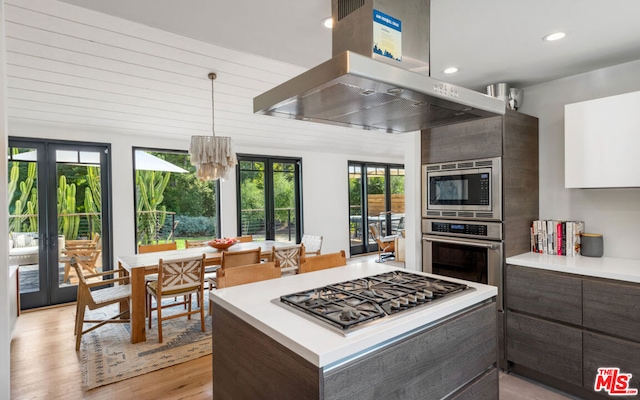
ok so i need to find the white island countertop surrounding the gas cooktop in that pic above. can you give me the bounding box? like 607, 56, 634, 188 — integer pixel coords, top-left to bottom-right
209, 261, 497, 368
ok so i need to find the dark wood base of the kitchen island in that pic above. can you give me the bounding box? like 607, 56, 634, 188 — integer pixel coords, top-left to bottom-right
212, 298, 498, 400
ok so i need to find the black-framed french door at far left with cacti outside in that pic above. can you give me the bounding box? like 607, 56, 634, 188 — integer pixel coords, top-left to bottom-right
7, 138, 112, 309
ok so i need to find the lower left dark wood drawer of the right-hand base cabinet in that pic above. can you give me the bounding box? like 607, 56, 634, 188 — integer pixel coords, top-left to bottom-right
507, 311, 582, 386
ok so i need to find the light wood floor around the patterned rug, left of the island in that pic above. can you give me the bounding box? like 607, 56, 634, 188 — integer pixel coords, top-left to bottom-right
11, 306, 213, 400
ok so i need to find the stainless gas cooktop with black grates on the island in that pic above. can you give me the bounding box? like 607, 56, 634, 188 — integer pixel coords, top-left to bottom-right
280, 271, 474, 333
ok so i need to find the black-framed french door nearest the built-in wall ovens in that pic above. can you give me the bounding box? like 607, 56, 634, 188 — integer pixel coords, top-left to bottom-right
349, 161, 405, 255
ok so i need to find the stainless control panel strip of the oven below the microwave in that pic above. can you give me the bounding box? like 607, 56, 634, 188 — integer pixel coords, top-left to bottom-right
422, 219, 502, 240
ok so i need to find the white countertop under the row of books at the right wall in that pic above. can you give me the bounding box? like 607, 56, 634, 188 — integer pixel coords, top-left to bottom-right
507, 253, 640, 283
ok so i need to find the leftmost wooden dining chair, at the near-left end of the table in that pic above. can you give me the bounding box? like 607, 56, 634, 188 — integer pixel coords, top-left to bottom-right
69, 258, 131, 351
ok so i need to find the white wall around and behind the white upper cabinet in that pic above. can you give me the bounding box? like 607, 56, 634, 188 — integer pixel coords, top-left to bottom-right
520, 61, 640, 259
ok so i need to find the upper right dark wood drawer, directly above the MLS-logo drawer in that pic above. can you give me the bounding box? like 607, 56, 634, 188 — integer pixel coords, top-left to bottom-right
583, 279, 640, 342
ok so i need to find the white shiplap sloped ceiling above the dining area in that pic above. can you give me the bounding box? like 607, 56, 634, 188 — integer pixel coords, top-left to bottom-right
5, 0, 404, 162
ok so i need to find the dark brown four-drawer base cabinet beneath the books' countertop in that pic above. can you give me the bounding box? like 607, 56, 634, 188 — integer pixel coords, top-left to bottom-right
505, 265, 640, 399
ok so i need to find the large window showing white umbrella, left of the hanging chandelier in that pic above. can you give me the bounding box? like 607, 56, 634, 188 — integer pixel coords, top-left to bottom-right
134, 148, 220, 249
